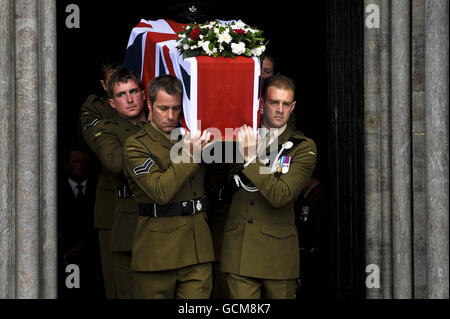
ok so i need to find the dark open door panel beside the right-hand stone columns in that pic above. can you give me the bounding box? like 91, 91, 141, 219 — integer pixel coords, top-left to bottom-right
327, 0, 365, 298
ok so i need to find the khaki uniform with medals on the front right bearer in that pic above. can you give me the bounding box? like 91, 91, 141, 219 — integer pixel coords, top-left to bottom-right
221, 125, 317, 298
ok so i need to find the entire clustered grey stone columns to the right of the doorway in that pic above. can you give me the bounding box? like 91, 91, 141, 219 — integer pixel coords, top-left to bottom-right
364, 0, 449, 298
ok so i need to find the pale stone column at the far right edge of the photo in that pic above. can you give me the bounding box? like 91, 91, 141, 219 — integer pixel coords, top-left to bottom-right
425, 0, 449, 298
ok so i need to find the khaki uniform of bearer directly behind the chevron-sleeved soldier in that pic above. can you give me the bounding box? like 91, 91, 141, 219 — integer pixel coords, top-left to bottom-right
94, 117, 143, 298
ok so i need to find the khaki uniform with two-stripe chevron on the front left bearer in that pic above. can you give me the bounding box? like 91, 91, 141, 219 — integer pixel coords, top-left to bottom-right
124, 123, 214, 298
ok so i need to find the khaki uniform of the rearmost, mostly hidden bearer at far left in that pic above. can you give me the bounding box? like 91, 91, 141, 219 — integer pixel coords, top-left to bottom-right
81, 94, 118, 299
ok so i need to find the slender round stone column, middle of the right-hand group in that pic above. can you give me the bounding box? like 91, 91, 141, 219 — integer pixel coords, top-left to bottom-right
391, 0, 413, 298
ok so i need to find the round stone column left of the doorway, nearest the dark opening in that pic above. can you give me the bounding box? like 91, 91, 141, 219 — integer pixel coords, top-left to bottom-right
38, 0, 58, 298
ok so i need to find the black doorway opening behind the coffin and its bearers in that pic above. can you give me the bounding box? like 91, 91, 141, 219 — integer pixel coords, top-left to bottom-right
57, 0, 364, 298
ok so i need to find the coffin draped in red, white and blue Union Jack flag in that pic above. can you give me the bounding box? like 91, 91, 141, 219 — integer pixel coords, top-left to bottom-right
124, 19, 260, 139
